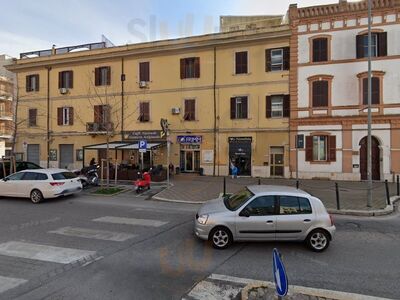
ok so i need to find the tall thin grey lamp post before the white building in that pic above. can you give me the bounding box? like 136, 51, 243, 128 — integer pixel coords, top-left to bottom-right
367, 0, 372, 207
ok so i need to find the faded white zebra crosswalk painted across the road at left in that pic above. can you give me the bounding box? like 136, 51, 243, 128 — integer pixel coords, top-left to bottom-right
0, 215, 169, 299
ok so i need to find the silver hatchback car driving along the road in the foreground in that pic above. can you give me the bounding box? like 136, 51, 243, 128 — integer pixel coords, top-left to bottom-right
195, 185, 336, 252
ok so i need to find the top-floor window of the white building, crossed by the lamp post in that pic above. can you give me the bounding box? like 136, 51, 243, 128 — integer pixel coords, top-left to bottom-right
356, 32, 387, 58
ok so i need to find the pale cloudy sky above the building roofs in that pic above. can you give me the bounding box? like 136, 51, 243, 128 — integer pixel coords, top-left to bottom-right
0, 0, 337, 57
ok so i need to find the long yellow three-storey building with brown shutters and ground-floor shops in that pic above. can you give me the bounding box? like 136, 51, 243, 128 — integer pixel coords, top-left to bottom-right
8, 22, 290, 177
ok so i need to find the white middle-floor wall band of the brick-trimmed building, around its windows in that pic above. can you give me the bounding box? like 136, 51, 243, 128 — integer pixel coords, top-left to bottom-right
298, 59, 400, 109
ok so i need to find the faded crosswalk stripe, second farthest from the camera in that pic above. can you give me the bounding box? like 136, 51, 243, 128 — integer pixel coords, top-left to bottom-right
49, 226, 137, 242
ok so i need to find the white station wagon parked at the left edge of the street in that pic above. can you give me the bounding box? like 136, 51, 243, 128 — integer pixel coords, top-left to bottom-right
0, 169, 82, 203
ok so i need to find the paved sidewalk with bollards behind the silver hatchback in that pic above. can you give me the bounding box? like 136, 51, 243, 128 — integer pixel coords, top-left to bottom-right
153, 174, 397, 211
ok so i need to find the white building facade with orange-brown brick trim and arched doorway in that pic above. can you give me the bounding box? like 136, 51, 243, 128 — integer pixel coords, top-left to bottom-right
289, 0, 400, 180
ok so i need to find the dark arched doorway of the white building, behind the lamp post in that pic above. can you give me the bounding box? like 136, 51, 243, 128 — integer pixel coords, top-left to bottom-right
360, 137, 381, 180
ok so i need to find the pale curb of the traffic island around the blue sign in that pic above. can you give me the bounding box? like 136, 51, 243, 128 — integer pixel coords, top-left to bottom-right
240, 281, 389, 300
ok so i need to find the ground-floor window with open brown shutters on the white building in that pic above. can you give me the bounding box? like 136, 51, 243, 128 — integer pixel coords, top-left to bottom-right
306, 134, 336, 162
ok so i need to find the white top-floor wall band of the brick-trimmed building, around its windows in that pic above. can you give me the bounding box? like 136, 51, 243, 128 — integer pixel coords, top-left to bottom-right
299, 24, 400, 63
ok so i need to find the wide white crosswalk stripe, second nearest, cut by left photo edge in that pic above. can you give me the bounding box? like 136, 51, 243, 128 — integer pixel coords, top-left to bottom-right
0, 241, 96, 264
